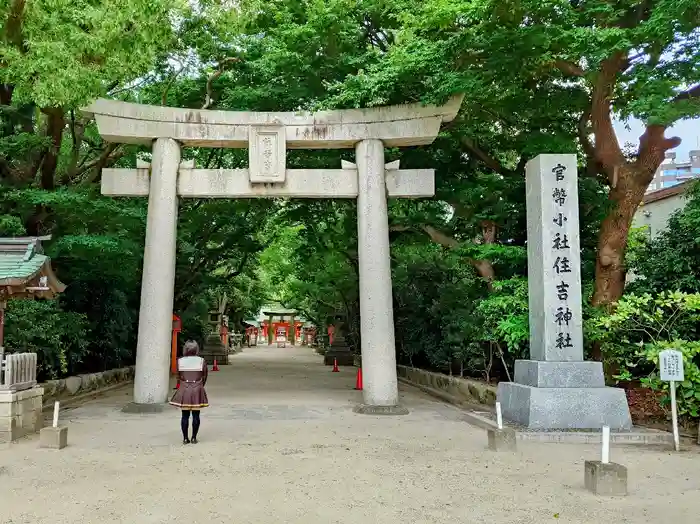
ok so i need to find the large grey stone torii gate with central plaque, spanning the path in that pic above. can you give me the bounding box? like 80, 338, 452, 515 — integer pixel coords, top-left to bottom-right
84, 96, 462, 413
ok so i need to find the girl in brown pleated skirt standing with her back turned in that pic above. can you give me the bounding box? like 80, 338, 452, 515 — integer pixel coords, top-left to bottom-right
170, 340, 209, 444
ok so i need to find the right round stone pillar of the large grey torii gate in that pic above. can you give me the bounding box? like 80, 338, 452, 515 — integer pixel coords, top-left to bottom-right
356, 139, 407, 414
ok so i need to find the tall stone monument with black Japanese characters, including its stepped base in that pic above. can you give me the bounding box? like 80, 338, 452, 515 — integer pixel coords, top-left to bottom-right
498, 154, 632, 429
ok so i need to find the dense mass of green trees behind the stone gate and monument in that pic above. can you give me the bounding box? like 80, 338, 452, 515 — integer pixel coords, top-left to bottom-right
0, 0, 700, 406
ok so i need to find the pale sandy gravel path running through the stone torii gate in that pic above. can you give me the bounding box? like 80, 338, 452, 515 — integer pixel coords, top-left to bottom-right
0, 347, 700, 524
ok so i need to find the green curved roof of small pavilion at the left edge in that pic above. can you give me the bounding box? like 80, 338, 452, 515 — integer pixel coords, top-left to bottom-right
0, 237, 65, 298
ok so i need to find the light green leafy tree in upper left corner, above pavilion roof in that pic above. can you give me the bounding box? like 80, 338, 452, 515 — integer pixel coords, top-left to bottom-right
0, 0, 183, 189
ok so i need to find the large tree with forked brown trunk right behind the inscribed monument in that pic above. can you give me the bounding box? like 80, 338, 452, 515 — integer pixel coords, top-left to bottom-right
326, 0, 700, 305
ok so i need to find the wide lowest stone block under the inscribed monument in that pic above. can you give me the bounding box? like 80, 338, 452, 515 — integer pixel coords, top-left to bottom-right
498, 382, 632, 430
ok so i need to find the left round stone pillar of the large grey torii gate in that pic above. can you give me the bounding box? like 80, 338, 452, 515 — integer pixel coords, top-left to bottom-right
124, 138, 180, 411
